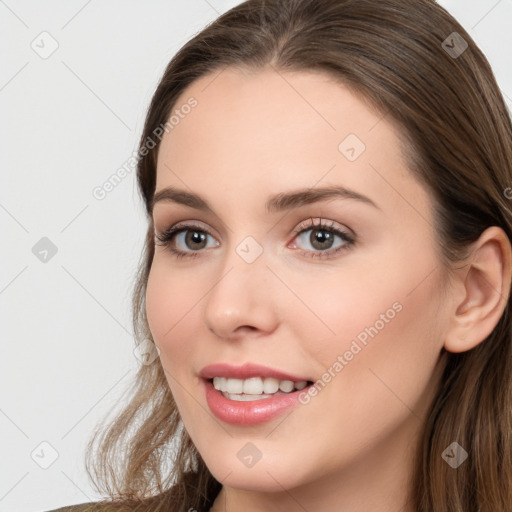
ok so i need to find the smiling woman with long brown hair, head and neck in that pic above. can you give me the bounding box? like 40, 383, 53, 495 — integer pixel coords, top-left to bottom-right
47, 0, 512, 512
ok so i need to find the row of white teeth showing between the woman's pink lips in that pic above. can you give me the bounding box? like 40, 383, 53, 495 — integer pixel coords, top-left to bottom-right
213, 377, 307, 400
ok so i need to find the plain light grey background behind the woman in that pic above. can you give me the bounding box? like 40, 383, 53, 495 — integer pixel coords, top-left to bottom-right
0, 0, 512, 512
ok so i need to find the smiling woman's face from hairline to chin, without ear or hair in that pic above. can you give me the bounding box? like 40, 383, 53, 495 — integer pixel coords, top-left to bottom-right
146, 69, 448, 500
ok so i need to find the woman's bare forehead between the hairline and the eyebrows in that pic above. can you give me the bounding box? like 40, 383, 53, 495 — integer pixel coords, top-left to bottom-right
156, 68, 427, 221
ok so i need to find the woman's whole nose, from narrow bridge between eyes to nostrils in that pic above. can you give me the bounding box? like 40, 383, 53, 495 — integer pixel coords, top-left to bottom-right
205, 236, 277, 338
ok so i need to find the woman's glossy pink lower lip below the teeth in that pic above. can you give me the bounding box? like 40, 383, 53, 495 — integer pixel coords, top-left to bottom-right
203, 379, 309, 425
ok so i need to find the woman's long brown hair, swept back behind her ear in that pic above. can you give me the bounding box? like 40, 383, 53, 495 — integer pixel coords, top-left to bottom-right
86, 0, 512, 512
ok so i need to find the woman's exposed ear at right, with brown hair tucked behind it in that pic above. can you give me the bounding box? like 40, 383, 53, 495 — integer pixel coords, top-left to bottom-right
444, 226, 512, 352
